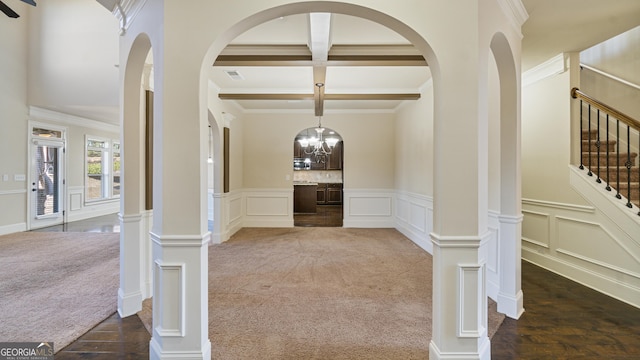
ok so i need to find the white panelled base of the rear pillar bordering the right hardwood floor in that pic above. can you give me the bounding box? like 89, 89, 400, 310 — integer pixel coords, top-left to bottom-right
497, 215, 524, 319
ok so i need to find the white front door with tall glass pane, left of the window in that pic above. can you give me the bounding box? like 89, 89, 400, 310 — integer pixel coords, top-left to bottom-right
30, 128, 64, 229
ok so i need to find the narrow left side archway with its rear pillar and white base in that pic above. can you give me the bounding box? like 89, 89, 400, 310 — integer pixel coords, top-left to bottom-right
118, 33, 153, 317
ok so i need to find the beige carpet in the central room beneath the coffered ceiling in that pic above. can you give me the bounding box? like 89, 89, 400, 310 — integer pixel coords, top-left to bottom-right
139, 227, 504, 360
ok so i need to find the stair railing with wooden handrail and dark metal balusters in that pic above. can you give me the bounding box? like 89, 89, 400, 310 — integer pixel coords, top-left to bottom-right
571, 88, 640, 216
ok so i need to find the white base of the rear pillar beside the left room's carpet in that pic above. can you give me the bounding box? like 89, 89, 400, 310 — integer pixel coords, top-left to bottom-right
118, 214, 145, 317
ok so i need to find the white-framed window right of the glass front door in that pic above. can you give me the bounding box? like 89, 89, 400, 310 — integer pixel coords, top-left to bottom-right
85, 137, 120, 201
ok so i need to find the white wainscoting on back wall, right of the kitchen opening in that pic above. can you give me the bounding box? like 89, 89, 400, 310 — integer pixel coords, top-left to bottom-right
343, 189, 395, 228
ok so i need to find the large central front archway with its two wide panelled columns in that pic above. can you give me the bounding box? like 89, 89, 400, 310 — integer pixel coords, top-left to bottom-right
114, 0, 524, 358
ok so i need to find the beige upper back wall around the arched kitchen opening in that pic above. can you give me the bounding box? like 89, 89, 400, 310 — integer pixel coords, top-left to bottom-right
242, 113, 395, 189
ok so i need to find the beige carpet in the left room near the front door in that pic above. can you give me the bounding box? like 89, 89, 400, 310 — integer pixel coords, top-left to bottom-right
0, 232, 120, 352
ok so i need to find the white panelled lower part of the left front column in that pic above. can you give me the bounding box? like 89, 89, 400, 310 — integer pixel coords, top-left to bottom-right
150, 233, 211, 360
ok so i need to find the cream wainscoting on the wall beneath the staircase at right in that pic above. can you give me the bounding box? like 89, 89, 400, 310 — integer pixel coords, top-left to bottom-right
522, 194, 640, 307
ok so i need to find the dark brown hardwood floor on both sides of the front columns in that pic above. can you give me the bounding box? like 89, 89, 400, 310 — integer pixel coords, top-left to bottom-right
37, 217, 640, 360
